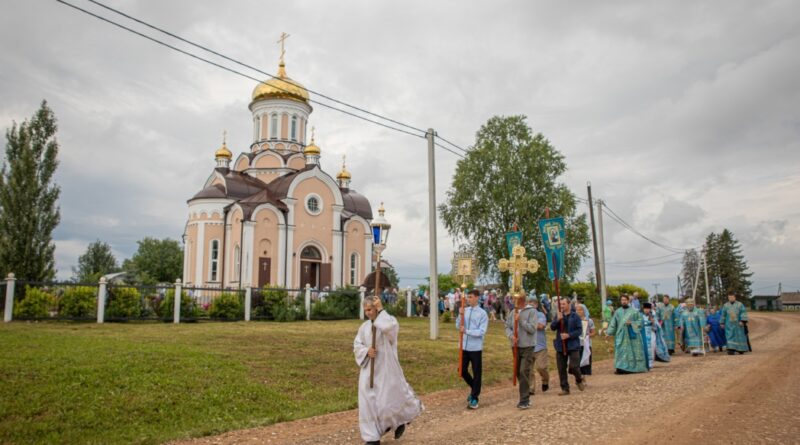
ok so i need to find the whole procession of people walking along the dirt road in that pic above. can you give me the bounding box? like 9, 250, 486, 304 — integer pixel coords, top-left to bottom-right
354, 289, 751, 444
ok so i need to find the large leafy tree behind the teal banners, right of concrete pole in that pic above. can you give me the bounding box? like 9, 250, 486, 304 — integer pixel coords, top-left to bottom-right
439, 116, 589, 291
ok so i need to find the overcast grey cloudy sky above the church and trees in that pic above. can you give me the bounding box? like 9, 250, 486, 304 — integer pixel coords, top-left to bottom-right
0, 0, 800, 294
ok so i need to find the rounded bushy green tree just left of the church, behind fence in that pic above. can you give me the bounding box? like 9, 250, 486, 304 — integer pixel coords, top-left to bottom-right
122, 237, 183, 284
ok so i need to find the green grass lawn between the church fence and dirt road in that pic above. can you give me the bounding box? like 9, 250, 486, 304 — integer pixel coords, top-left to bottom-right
0, 318, 606, 444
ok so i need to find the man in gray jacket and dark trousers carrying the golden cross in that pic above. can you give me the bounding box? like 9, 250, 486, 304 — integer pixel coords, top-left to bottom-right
506, 295, 538, 409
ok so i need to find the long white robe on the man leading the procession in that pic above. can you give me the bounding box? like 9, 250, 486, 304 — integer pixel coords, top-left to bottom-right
353, 311, 425, 442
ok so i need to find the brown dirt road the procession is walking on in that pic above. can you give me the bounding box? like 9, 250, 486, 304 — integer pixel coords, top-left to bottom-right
173, 314, 800, 445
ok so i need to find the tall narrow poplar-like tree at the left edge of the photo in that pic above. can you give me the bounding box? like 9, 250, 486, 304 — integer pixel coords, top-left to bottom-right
0, 101, 61, 281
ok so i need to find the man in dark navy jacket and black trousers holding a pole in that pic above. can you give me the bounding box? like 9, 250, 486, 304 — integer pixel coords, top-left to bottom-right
550, 298, 585, 396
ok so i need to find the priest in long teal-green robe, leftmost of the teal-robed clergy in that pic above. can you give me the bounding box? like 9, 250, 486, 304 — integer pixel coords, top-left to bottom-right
606, 295, 647, 374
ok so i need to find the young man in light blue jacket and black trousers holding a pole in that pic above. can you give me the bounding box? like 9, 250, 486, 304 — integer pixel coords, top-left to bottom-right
456, 289, 489, 409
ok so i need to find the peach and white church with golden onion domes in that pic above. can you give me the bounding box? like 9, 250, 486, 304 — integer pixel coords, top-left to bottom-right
183, 48, 373, 289
